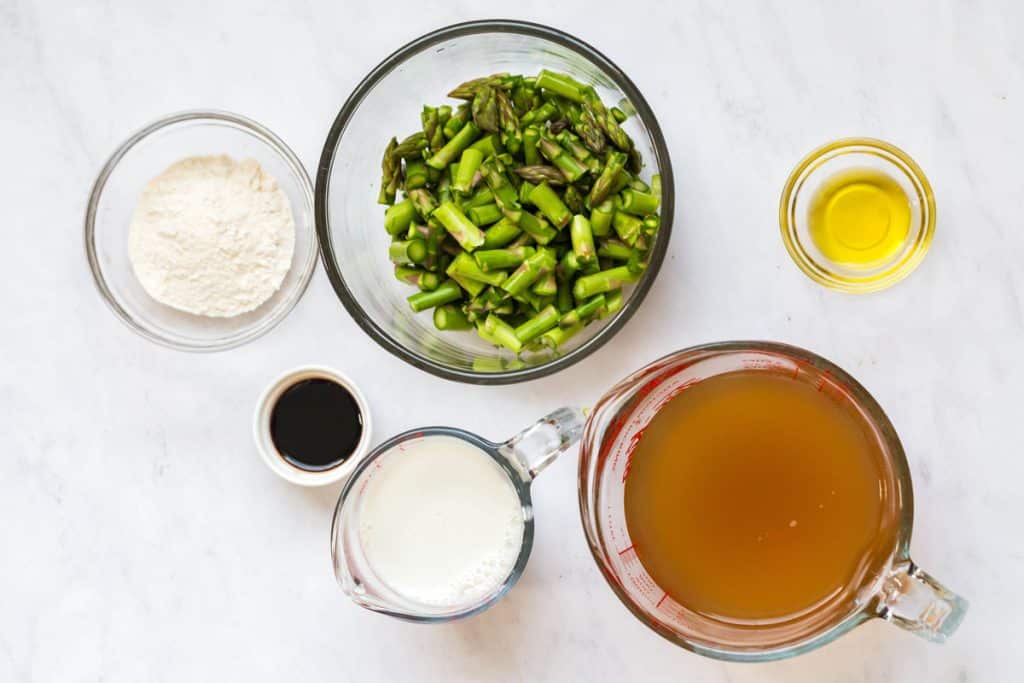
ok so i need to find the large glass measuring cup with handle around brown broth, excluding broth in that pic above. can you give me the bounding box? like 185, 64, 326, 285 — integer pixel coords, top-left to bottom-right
580, 342, 967, 661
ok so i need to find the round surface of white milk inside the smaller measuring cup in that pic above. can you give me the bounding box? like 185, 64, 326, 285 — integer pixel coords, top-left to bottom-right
359, 436, 523, 607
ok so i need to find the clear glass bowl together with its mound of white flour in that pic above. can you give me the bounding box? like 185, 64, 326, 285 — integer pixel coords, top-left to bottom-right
85, 112, 317, 351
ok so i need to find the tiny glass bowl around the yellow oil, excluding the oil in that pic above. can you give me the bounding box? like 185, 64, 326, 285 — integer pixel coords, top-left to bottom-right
778, 137, 935, 293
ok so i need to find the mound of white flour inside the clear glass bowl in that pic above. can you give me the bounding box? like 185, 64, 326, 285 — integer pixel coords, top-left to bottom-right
128, 156, 295, 317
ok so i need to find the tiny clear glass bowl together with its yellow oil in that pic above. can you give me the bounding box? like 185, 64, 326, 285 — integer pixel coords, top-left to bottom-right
778, 138, 935, 293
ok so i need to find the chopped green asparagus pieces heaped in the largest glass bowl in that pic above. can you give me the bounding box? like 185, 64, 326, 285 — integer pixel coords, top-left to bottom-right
378, 70, 662, 352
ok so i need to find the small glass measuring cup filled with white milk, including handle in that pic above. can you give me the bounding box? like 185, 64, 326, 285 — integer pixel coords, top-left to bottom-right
331, 408, 584, 624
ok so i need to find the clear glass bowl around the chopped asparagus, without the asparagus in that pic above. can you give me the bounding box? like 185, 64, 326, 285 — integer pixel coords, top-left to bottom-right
316, 20, 674, 384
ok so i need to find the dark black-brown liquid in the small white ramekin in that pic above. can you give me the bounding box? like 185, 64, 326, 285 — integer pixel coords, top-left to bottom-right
270, 379, 362, 471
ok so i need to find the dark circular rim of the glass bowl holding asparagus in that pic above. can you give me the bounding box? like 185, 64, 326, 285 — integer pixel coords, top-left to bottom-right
314, 19, 675, 385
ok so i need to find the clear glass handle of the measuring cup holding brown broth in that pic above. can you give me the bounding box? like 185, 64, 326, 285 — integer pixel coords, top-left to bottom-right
879, 560, 968, 643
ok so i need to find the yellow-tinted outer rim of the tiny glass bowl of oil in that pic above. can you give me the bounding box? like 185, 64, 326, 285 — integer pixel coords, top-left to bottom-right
778, 137, 936, 294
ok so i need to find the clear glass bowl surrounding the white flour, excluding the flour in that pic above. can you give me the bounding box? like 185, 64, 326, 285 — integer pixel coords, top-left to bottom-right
85, 112, 316, 351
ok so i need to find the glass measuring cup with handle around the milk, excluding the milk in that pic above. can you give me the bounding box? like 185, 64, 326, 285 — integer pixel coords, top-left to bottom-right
331, 408, 584, 624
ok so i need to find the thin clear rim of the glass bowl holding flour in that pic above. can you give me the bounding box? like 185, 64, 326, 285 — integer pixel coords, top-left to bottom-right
85, 110, 318, 352
